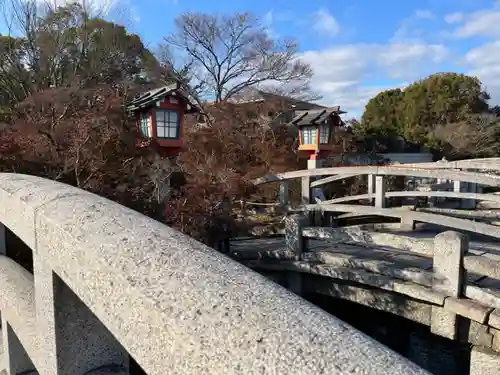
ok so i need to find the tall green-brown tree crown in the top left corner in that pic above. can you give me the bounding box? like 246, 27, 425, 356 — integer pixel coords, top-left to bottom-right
0, 3, 158, 106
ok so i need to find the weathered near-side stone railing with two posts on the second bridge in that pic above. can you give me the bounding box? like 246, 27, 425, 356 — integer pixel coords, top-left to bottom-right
284, 214, 500, 351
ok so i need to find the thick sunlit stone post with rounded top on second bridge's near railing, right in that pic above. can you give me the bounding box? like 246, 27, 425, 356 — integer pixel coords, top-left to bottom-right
431, 231, 469, 340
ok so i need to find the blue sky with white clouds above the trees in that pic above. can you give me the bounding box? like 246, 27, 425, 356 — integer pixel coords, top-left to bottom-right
0, 0, 500, 116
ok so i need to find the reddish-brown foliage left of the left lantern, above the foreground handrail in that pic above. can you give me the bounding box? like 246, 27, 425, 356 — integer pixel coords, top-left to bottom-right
0, 86, 168, 216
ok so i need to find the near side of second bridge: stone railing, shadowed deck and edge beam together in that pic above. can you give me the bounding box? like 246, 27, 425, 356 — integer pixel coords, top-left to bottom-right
244, 214, 500, 375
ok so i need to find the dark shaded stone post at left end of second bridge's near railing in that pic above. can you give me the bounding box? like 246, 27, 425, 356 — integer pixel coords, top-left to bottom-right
285, 214, 309, 295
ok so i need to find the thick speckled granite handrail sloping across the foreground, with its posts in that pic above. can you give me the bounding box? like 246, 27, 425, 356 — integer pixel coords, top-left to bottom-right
0, 174, 426, 375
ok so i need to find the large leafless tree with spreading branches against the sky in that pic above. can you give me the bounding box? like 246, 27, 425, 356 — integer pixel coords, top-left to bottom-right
160, 13, 312, 102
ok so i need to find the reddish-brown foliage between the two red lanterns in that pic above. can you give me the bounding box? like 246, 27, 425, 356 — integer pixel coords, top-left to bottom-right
165, 103, 300, 245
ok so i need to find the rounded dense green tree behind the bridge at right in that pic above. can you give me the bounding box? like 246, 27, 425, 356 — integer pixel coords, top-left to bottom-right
354, 73, 489, 151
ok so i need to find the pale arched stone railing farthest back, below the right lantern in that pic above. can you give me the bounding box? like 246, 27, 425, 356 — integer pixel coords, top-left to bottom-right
254, 158, 500, 229
